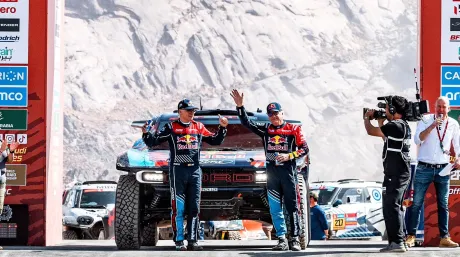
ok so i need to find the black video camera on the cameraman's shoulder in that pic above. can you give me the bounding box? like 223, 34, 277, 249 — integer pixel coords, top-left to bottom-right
363, 95, 430, 121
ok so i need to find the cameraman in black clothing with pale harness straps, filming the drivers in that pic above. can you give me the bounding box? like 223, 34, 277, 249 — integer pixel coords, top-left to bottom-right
364, 96, 411, 252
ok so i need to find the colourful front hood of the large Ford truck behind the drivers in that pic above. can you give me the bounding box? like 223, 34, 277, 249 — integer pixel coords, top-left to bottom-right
117, 139, 265, 170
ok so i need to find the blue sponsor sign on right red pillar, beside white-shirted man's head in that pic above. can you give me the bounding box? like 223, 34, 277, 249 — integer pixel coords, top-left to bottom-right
441, 66, 460, 107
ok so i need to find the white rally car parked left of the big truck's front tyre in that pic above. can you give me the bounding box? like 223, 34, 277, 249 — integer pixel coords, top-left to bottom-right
62, 181, 117, 240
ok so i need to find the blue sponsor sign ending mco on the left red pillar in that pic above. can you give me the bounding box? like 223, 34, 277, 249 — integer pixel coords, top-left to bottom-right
0, 66, 28, 107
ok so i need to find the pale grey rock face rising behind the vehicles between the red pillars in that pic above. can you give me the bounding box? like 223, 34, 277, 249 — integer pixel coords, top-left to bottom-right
64, 0, 417, 183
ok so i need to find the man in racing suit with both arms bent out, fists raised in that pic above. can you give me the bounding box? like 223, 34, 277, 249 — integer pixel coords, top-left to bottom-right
142, 99, 228, 251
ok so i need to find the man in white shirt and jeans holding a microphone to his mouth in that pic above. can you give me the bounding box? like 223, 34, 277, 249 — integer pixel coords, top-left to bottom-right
406, 97, 460, 247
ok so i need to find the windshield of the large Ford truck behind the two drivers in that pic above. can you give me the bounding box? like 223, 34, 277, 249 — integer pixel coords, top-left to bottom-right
152, 122, 263, 151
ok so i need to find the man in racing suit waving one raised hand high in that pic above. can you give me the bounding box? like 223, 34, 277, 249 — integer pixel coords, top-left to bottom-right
231, 89, 309, 251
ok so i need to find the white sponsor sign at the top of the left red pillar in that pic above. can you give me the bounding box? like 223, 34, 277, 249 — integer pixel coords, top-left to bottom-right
0, 0, 29, 64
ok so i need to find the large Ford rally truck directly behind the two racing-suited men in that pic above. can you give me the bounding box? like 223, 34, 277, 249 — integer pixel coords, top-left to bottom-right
114, 109, 310, 250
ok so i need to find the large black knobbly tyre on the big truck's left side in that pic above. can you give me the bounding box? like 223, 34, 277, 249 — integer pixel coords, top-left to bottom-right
114, 175, 142, 250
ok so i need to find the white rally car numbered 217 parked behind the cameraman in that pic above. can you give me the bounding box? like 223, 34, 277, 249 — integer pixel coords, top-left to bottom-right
310, 179, 387, 240
